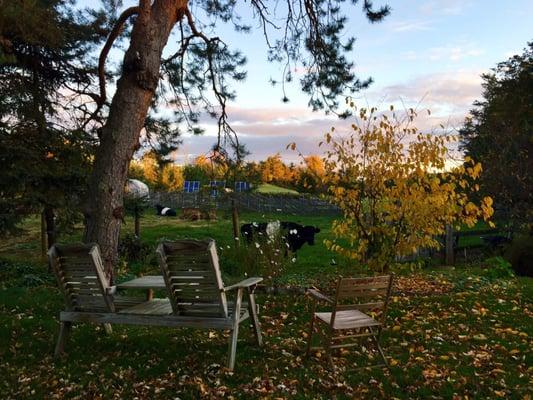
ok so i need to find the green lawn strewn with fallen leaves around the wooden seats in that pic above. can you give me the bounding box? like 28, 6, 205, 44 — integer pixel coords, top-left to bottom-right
0, 214, 533, 399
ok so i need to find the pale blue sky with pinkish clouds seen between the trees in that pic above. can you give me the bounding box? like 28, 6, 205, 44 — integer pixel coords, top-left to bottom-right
96, 0, 533, 164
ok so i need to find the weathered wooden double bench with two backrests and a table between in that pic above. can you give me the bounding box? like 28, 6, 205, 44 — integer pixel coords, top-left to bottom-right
48, 241, 262, 369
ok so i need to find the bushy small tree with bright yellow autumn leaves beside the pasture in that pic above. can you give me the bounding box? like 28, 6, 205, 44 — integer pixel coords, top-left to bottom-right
314, 103, 493, 271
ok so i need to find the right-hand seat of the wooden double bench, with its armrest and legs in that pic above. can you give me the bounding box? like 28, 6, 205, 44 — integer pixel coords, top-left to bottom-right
156, 239, 263, 369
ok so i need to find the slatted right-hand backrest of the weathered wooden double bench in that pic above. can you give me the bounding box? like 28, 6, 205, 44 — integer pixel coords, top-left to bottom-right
156, 239, 228, 318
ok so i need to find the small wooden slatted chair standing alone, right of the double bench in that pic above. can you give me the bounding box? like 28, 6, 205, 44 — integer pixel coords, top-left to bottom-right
306, 275, 393, 368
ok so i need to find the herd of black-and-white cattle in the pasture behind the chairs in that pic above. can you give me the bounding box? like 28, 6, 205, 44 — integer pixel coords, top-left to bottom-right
156, 204, 320, 253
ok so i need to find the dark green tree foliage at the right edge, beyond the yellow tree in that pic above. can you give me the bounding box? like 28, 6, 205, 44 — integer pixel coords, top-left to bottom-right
460, 42, 533, 224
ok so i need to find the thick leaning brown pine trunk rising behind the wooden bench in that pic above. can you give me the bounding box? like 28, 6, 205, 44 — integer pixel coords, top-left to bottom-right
84, 0, 187, 282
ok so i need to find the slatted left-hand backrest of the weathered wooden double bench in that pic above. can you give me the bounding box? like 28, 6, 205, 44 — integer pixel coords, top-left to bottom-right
48, 244, 115, 312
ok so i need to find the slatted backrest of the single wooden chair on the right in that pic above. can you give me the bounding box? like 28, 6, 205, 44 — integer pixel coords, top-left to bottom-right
332, 275, 393, 323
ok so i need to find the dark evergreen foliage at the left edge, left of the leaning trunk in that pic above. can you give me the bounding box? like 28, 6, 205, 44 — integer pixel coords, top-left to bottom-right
0, 0, 104, 236
